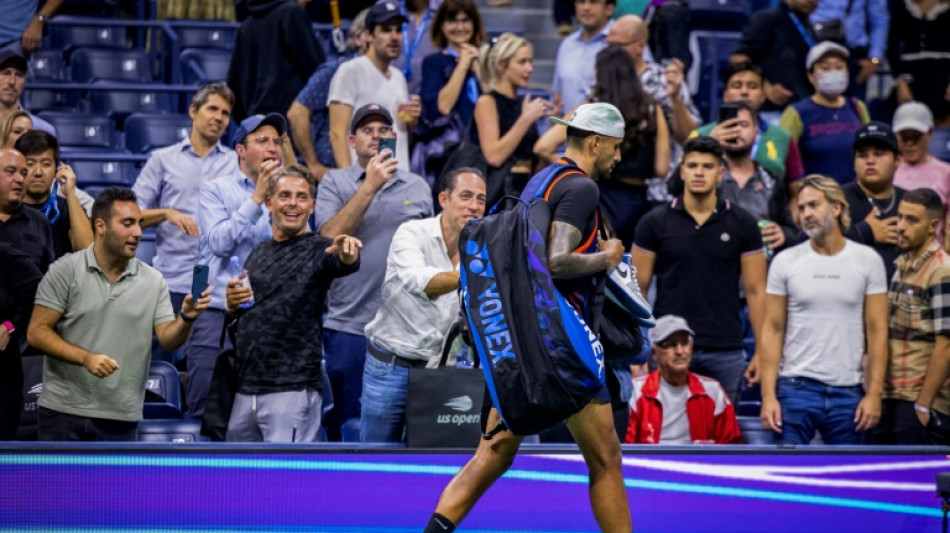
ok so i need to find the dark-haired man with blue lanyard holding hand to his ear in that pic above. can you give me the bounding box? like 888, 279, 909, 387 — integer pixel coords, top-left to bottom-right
14, 130, 93, 259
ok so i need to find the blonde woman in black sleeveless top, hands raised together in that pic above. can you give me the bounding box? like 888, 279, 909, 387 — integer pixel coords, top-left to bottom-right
474, 33, 554, 205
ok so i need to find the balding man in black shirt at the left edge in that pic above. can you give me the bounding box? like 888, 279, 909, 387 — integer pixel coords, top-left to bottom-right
0, 148, 54, 273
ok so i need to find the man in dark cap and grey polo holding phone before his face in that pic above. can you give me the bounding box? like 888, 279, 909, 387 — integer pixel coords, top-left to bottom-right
314, 104, 432, 440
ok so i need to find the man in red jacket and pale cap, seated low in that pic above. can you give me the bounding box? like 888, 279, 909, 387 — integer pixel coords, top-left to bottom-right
624, 315, 742, 444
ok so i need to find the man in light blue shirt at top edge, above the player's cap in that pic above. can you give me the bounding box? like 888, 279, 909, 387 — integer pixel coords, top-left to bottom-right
551, 0, 617, 113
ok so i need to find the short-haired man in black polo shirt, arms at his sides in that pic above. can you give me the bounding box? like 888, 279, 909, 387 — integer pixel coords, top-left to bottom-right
632, 136, 766, 402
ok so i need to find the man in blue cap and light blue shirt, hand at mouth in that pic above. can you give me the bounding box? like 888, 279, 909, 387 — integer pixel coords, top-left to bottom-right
185, 113, 287, 418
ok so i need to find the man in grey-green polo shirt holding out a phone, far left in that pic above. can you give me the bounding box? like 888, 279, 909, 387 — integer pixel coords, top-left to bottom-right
27, 187, 211, 441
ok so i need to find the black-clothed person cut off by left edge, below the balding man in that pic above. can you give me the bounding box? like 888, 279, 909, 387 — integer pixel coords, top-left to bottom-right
0, 242, 43, 440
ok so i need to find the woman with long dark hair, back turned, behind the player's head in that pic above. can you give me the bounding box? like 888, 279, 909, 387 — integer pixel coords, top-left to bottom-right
534, 47, 670, 248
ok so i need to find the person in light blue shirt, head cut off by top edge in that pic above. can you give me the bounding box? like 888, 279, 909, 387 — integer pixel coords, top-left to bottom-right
808, 0, 891, 100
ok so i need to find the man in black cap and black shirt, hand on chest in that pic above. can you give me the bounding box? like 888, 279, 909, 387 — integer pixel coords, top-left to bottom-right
842, 122, 906, 279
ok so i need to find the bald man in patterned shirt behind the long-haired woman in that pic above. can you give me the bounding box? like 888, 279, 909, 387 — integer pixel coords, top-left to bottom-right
607, 15, 702, 144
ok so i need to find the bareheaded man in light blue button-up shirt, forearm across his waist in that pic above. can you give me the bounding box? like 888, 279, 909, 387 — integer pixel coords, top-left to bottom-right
132, 83, 238, 324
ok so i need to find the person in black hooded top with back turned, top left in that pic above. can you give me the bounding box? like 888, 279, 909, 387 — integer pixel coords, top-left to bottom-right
228, 0, 326, 121
